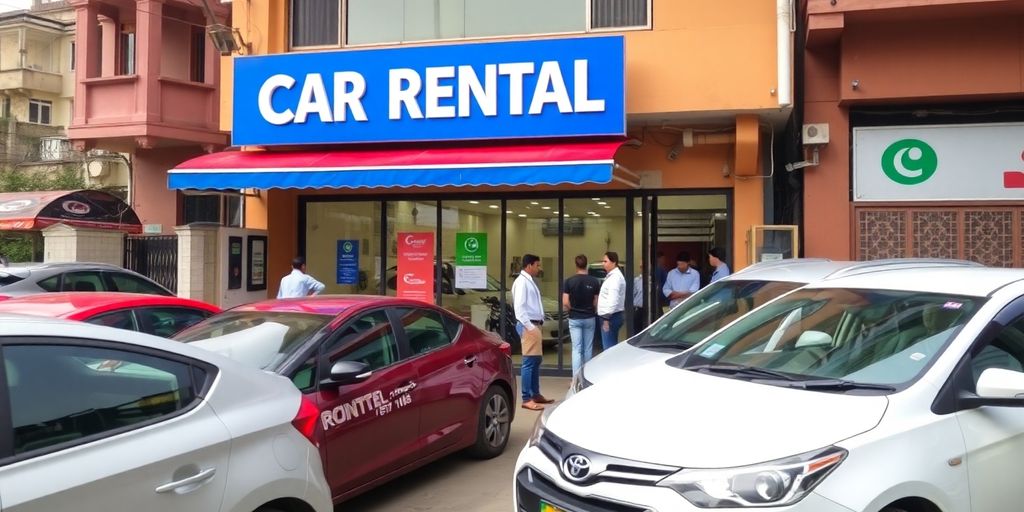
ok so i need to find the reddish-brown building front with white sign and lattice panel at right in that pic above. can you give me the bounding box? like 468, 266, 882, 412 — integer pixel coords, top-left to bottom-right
799, 0, 1024, 266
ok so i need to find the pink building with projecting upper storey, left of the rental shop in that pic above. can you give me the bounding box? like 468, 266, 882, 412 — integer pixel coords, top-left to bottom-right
68, 0, 233, 233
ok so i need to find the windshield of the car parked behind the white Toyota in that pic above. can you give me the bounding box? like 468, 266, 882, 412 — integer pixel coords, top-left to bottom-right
630, 280, 802, 348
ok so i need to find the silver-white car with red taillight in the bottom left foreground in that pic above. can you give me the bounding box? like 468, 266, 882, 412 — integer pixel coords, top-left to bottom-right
0, 315, 332, 512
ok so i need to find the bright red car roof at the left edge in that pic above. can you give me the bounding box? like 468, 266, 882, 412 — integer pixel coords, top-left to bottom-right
0, 292, 220, 317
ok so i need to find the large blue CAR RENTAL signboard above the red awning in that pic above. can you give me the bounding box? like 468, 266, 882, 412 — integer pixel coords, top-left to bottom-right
231, 36, 626, 145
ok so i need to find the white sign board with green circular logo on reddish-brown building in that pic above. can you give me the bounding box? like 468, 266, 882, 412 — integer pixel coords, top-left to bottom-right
853, 123, 1024, 201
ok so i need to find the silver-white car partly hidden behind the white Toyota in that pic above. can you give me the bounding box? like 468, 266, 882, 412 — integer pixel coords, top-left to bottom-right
566, 258, 981, 397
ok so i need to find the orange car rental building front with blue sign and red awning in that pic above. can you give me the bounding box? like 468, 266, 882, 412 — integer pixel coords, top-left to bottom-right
180, 0, 795, 368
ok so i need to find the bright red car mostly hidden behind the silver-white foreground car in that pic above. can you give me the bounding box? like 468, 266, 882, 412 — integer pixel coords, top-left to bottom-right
0, 292, 220, 338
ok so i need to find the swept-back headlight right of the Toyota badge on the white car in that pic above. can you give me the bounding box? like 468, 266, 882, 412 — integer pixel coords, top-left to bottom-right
657, 446, 847, 508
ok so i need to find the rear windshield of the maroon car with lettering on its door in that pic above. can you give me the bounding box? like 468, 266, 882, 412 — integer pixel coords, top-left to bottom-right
174, 311, 334, 371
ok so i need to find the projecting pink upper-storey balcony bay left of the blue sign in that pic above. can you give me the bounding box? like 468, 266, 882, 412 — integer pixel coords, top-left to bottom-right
68, 0, 228, 151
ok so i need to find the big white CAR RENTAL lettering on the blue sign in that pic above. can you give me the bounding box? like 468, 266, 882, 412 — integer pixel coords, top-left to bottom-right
257, 59, 605, 126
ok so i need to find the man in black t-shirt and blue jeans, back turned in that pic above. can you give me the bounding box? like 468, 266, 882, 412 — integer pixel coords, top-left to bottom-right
562, 254, 601, 375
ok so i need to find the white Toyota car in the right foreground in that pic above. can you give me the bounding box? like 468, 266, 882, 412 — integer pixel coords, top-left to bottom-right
514, 267, 1024, 512
